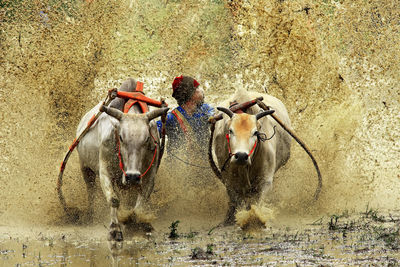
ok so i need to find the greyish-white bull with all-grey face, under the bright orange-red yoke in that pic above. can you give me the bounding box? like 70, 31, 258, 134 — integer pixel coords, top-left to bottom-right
77, 91, 168, 245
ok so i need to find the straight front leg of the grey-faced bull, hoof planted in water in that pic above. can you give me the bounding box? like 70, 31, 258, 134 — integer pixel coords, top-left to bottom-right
100, 166, 123, 248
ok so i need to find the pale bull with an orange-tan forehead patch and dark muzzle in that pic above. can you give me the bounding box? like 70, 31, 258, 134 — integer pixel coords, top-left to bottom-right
212, 91, 291, 224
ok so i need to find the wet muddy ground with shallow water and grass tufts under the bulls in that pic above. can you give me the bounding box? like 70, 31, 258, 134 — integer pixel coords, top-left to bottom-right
0, 209, 400, 266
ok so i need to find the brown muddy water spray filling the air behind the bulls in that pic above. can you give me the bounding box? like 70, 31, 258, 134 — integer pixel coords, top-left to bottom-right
0, 0, 400, 233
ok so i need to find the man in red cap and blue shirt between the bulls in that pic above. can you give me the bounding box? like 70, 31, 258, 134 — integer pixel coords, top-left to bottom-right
157, 76, 214, 159
